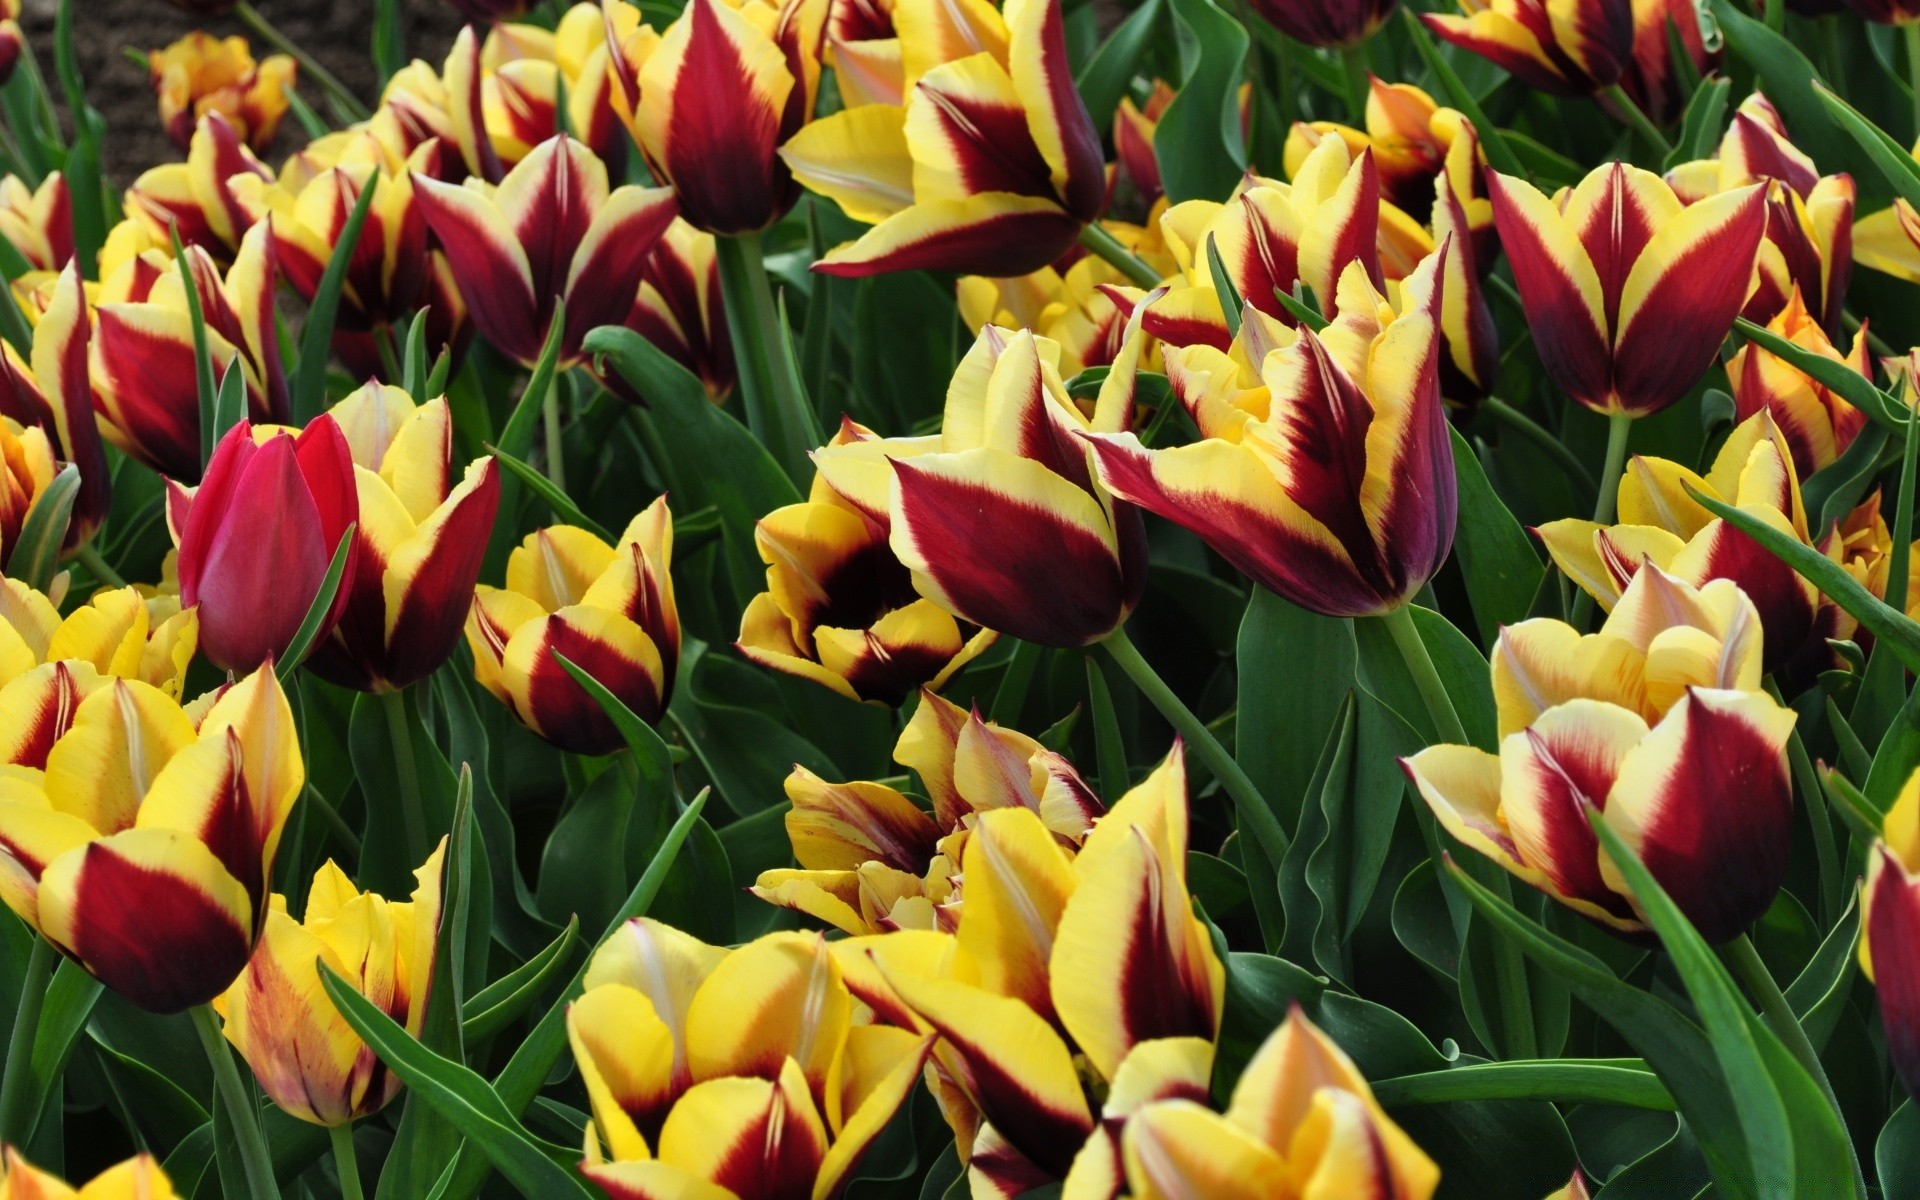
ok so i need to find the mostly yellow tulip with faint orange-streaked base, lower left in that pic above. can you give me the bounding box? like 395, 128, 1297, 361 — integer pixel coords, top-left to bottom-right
213, 837, 447, 1125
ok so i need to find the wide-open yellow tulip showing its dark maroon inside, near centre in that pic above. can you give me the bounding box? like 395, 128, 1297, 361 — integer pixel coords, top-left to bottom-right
735, 420, 993, 708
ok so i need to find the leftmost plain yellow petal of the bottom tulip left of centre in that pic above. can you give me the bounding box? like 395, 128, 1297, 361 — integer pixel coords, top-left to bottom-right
566, 983, 676, 1160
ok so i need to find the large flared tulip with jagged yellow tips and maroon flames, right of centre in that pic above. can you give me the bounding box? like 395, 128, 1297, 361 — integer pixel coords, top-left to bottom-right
1091, 250, 1455, 616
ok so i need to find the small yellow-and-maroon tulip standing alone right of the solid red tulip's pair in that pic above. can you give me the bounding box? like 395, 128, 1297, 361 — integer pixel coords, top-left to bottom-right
467, 495, 680, 755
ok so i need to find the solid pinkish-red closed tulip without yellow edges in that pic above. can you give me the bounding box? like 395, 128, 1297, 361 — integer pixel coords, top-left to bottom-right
167, 415, 360, 672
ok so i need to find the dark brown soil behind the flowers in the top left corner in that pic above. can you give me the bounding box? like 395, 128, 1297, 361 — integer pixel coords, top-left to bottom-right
21, 0, 461, 186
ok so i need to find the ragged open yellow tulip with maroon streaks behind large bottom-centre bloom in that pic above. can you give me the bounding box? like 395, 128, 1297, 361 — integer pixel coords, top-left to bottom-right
753, 691, 1104, 935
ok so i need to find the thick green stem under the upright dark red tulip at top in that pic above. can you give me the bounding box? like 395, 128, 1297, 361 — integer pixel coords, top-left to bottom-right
714, 234, 822, 490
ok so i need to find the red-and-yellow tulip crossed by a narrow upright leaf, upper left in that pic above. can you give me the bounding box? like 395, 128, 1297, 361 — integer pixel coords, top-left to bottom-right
88, 223, 288, 481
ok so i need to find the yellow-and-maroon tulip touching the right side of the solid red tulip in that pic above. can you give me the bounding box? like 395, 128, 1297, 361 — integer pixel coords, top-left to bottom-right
309, 382, 499, 691
